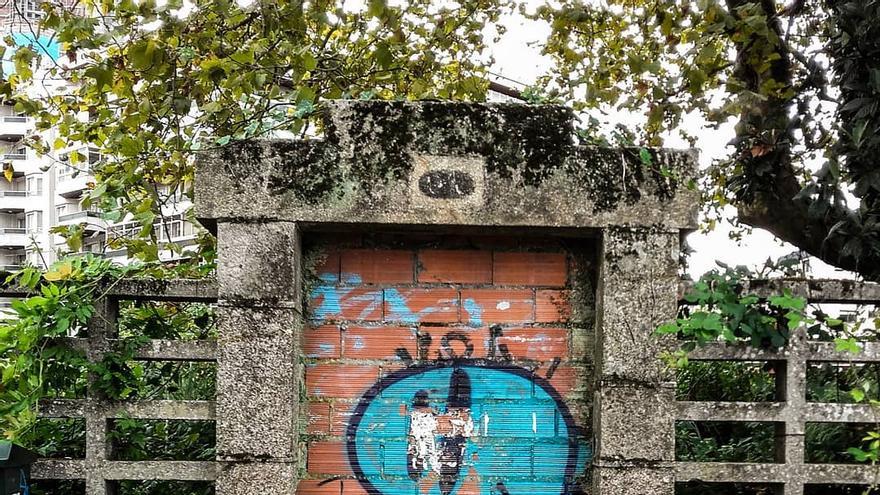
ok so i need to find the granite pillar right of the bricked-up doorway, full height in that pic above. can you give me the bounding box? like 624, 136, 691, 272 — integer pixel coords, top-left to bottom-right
593, 227, 680, 495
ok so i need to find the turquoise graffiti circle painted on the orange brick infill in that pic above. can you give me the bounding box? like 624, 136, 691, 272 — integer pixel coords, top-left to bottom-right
347, 360, 590, 495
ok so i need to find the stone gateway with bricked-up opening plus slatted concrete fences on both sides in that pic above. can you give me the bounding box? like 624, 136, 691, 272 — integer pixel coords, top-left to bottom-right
22, 102, 880, 495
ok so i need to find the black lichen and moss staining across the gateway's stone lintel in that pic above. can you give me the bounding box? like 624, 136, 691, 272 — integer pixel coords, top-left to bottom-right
208, 101, 692, 216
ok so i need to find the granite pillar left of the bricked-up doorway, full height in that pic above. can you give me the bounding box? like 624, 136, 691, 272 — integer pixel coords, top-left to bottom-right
217, 222, 302, 495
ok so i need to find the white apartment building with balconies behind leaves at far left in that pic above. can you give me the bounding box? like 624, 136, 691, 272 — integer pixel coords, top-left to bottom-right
0, 4, 196, 271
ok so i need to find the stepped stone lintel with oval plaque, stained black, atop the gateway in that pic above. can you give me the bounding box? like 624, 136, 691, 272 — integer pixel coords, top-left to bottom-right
195, 101, 698, 230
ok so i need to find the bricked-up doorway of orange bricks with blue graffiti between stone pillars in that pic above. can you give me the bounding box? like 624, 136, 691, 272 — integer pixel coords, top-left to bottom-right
298, 234, 595, 495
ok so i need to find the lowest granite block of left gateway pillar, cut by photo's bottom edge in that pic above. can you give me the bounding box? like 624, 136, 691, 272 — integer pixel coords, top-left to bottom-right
216, 462, 297, 495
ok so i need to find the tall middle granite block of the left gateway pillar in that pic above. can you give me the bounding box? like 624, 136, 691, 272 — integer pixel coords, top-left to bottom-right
217, 307, 302, 463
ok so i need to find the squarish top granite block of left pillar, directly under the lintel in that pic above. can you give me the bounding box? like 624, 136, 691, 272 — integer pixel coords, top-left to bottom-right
217, 222, 302, 309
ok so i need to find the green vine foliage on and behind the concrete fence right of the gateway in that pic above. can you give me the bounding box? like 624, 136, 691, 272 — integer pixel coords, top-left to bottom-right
655, 266, 880, 472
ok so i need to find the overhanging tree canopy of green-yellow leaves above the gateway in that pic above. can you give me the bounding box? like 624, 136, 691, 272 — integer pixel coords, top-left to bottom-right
0, 0, 880, 279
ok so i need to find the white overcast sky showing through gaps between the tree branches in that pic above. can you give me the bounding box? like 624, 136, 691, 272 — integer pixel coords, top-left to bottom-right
492, 7, 852, 278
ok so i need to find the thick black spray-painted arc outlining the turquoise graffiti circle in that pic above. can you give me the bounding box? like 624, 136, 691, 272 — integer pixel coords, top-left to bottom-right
345, 359, 579, 495
